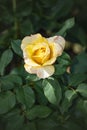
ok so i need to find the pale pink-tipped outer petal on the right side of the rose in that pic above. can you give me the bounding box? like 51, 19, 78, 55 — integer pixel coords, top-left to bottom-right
43, 36, 65, 66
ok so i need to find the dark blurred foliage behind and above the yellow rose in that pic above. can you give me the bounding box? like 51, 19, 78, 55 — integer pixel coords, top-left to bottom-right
0, 0, 87, 54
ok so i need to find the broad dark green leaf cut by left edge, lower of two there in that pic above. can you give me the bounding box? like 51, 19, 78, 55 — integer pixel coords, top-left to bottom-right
0, 91, 16, 114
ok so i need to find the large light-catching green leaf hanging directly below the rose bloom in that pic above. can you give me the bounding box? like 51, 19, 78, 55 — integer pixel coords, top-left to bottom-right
43, 79, 62, 105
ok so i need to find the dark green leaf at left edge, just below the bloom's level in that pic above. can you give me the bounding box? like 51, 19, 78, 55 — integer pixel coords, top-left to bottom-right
0, 74, 22, 90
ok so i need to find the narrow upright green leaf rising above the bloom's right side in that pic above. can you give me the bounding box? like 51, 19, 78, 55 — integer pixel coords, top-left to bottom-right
57, 18, 75, 36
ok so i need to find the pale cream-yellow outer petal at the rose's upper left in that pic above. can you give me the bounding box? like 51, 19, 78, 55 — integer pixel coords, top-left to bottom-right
21, 33, 41, 50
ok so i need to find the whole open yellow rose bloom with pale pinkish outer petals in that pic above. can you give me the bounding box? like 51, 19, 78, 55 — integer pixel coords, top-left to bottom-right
21, 34, 65, 79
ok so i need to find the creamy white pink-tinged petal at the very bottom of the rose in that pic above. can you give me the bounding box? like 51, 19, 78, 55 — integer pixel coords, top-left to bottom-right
37, 65, 55, 79
